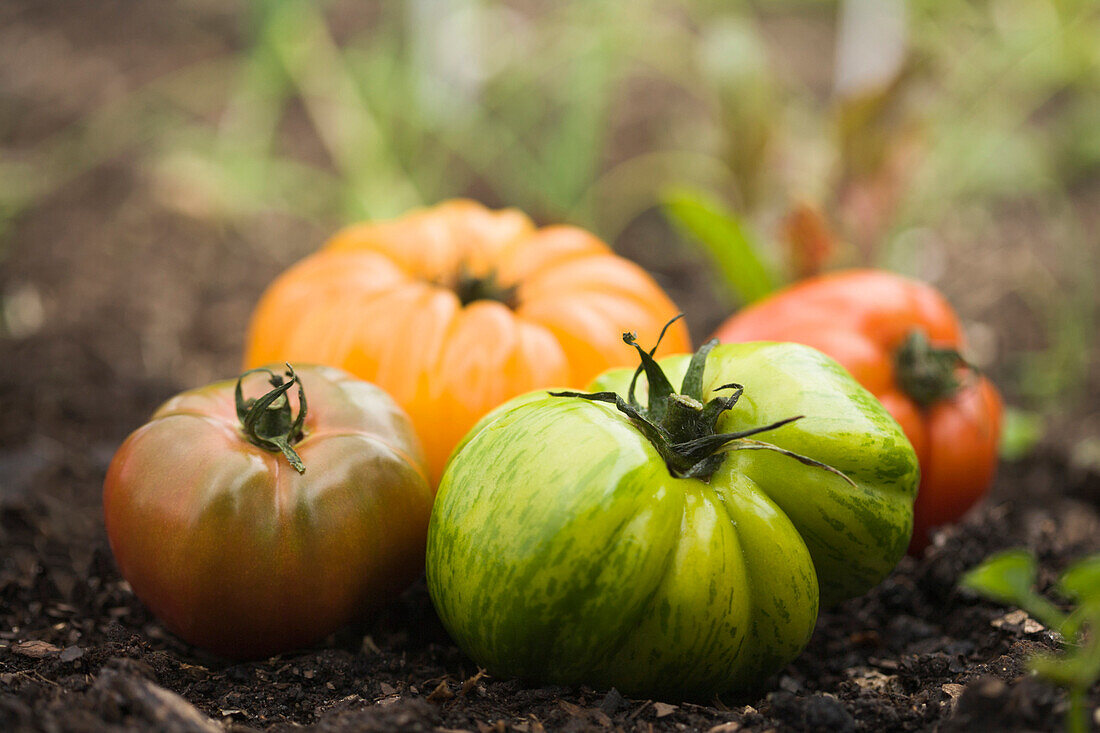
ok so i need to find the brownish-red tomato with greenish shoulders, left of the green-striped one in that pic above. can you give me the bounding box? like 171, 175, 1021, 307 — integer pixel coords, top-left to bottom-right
103, 367, 432, 658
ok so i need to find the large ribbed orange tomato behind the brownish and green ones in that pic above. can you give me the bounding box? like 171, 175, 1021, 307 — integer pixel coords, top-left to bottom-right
244, 200, 691, 481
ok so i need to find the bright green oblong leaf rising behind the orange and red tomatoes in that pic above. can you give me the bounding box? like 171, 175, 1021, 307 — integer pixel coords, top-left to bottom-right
661, 188, 778, 304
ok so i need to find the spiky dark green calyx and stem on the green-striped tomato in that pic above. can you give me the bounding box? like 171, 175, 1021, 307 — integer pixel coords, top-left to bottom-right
550, 314, 851, 483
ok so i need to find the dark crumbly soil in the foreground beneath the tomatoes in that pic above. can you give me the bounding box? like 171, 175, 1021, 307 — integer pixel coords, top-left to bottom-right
0, 435, 1100, 731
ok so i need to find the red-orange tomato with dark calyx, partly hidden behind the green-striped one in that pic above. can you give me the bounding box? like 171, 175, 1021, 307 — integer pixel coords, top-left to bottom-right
715, 270, 1003, 553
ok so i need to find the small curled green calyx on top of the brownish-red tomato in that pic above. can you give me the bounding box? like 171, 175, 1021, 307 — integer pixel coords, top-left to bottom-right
235, 364, 306, 473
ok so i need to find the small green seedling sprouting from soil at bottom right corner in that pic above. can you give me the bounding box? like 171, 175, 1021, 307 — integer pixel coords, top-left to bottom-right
959, 549, 1100, 733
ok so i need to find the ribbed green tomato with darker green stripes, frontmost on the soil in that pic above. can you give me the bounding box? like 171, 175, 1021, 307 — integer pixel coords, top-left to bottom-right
427, 341, 919, 698
